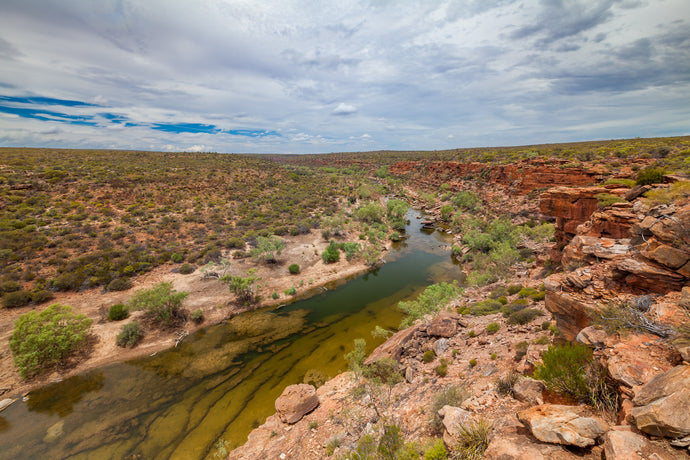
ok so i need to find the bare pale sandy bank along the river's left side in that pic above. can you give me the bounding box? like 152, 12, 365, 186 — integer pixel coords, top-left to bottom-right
0, 233, 391, 398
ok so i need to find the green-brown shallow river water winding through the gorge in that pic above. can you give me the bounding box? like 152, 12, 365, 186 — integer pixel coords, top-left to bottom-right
0, 211, 462, 460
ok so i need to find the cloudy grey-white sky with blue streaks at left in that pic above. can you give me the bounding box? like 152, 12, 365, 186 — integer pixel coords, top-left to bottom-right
0, 0, 690, 153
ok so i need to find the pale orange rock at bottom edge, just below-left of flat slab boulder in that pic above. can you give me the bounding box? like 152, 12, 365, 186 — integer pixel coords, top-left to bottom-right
484, 415, 580, 460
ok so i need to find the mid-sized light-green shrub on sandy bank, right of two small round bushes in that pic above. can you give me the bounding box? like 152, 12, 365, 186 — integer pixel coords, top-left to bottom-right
127, 283, 188, 327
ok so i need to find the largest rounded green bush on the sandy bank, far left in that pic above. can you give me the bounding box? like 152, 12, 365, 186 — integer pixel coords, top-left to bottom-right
10, 303, 91, 378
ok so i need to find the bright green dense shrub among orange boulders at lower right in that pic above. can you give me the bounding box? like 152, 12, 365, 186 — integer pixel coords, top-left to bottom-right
534, 343, 592, 402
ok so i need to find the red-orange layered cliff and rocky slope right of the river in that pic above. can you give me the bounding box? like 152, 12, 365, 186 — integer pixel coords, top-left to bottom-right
231, 172, 690, 460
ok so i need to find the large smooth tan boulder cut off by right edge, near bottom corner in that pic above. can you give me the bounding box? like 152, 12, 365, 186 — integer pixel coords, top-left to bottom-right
630, 365, 690, 438
